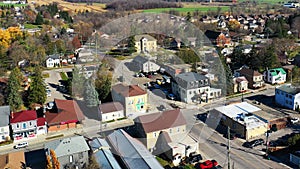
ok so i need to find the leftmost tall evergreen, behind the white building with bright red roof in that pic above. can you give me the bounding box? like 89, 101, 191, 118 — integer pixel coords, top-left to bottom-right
6, 68, 23, 111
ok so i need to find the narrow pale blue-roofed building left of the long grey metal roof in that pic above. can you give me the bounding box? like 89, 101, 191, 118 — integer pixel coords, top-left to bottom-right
89, 137, 121, 169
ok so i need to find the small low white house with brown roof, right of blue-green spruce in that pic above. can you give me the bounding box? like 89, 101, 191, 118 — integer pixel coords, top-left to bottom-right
99, 102, 125, 121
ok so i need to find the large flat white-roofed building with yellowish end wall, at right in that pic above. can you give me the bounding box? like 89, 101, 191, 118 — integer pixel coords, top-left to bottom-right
211, 102, 268, 140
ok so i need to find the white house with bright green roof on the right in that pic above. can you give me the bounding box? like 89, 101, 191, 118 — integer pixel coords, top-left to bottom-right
264, 68, 286, 84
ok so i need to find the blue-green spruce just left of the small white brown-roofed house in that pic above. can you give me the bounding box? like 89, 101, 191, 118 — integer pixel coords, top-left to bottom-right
83, 79, 99, 107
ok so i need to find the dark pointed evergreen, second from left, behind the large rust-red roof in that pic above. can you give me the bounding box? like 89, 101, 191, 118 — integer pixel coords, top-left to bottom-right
28, 66, 47, 105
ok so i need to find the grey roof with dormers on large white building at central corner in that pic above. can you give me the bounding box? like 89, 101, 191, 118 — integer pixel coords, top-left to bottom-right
175, 72, 210, 89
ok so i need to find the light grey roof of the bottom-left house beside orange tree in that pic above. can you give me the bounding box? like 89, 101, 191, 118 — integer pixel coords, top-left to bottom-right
45, 136, 90, 157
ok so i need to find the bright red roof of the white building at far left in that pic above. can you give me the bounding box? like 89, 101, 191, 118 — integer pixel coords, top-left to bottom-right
10, 110, 37, 123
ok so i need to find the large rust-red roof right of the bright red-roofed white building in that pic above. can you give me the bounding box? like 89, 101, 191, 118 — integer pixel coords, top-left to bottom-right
45, 99, 84, 125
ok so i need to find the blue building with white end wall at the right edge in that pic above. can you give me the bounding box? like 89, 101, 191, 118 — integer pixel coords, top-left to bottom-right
275, 84, 300, 110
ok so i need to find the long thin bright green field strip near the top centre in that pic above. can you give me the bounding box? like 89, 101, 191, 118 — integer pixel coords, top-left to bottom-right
143, 6, 229, 13
